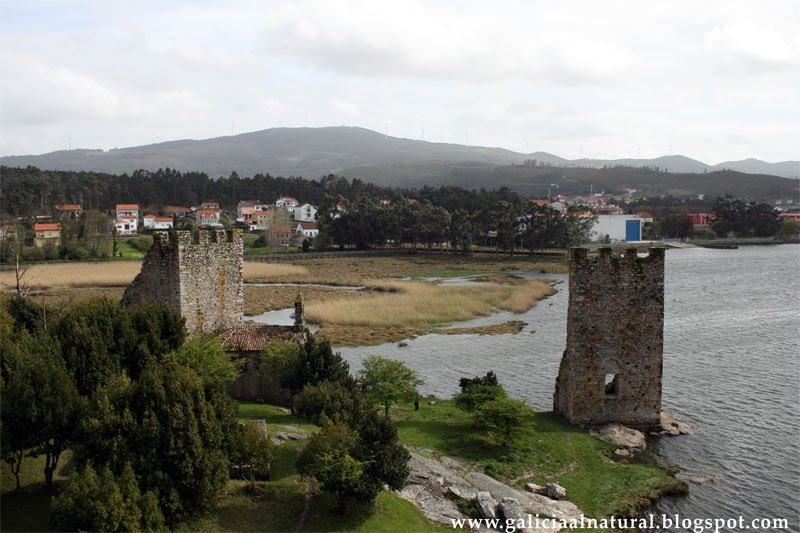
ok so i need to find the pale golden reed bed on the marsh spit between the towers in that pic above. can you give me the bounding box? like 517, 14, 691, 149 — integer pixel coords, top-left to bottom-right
306, 281, 555, 328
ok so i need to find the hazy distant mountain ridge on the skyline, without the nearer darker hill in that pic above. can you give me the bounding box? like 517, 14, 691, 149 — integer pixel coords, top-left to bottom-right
0, 126, 800, 178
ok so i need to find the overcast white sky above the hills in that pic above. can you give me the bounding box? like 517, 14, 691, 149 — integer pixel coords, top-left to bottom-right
0, 0, 800, 164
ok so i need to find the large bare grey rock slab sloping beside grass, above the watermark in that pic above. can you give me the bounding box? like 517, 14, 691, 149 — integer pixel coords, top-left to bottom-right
396, 449, 582, 526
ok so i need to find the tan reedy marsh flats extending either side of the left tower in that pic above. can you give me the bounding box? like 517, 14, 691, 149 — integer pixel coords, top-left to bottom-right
6, 256, 565, 345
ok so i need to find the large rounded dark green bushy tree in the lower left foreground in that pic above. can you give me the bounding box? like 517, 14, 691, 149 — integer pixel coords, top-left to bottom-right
78, 361, 235, 523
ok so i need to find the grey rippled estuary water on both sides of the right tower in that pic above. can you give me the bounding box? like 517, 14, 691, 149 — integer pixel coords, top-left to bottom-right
332, 245, 800, 531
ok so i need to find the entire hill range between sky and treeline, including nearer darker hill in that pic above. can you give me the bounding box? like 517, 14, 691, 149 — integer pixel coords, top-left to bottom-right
0, 127, 800, 199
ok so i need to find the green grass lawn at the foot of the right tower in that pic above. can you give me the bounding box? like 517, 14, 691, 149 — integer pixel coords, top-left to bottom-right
393, 399, 686, 518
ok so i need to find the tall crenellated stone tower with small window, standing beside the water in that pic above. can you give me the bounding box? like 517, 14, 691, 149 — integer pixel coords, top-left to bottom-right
553, 248, 664, 429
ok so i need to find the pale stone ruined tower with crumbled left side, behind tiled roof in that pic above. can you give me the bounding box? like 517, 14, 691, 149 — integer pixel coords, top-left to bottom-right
122, 230, 244, 332
